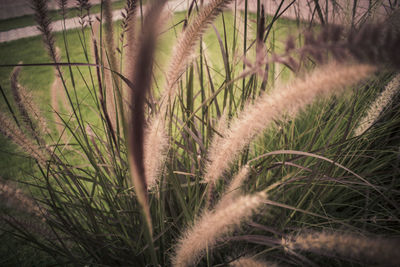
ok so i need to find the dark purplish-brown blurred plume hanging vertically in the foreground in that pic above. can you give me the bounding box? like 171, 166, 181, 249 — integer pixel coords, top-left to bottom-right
127, 1, 165, 241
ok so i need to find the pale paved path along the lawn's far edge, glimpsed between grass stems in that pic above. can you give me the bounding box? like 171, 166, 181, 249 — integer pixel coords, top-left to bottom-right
0, 0, 386, 43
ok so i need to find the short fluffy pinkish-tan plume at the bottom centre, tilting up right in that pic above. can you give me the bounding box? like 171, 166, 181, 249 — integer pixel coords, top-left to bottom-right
172, 193, 265, 267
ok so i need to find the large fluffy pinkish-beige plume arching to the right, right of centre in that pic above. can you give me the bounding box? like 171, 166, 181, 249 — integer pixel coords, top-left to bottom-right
204, 62, 376, 183
